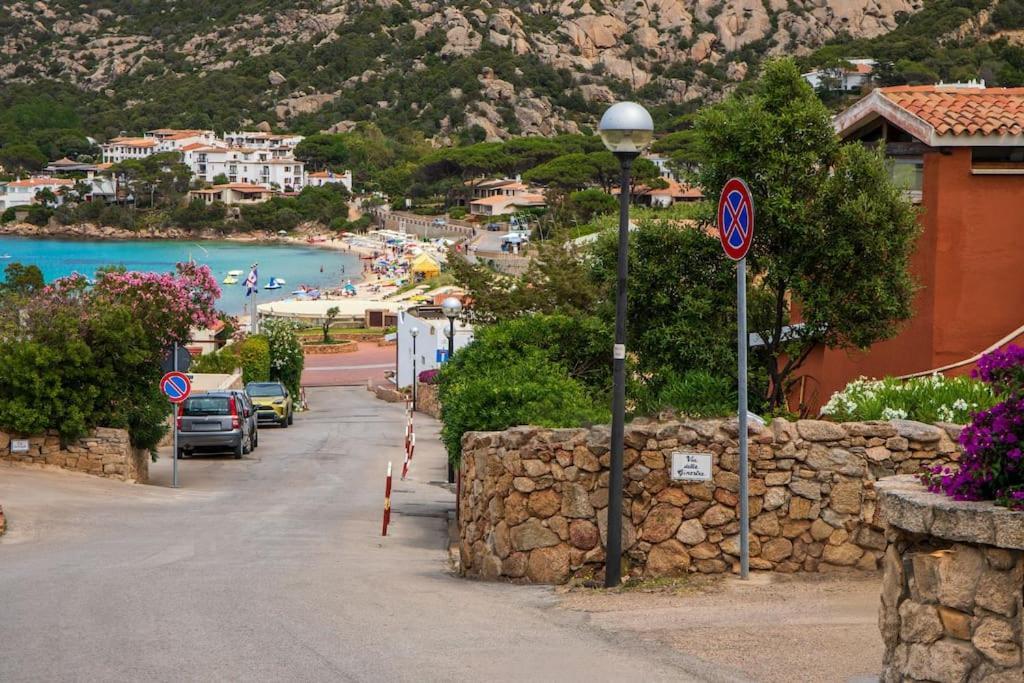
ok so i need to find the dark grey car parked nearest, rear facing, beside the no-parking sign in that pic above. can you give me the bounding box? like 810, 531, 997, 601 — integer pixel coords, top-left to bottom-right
176, 391, 255, 459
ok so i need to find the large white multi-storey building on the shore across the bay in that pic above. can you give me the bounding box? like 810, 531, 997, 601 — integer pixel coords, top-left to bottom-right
181, 143, 305, 193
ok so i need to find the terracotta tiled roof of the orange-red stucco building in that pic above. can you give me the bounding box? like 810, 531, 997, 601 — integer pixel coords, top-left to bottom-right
881, 85, 1024, 135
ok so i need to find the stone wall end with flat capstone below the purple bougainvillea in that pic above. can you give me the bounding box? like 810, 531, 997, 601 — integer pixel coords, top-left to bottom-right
879, 477, 1024, 683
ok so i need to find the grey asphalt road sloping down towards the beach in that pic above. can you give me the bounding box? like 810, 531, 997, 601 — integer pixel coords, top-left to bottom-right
0, 388, 725, 682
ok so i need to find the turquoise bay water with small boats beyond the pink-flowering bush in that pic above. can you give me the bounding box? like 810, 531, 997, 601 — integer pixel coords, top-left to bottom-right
0, 236, 361, 314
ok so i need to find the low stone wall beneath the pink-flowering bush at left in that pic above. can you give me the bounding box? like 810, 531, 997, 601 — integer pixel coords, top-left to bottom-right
0, 427, 150, 483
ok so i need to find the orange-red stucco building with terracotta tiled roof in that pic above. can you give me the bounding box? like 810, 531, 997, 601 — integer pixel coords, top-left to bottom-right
793, 85, 1024, 412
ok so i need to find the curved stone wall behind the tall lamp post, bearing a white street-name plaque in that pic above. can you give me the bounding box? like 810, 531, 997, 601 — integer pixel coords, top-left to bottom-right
459, 419, 959, 584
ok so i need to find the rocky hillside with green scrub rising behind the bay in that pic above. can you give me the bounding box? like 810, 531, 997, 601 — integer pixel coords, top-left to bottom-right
0, 0, 999, 139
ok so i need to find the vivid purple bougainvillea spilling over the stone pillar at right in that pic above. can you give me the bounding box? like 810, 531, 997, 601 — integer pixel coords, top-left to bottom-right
922, 346, 1024, 509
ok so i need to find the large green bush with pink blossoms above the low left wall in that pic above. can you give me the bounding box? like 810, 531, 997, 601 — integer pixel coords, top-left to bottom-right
0, 263, 220, 449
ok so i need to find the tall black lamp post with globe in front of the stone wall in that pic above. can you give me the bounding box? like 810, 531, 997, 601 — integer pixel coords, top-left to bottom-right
597, 102, 654, 588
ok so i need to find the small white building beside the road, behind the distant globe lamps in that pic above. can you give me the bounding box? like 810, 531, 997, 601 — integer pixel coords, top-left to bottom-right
395, 306, 473, 389
